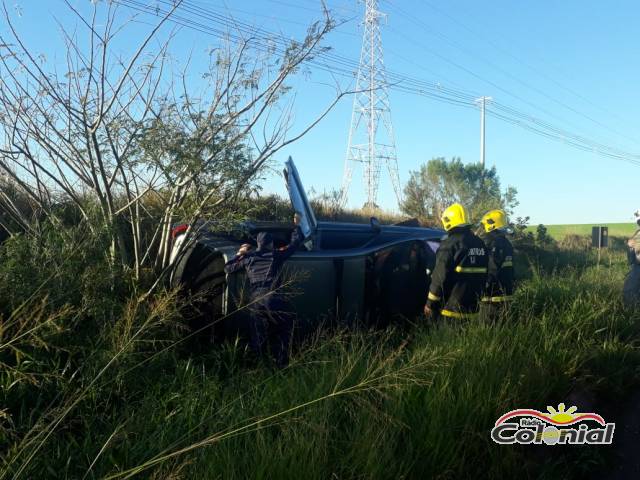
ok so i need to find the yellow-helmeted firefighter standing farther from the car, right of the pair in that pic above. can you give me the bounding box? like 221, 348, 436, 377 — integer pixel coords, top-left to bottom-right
480, 210, 513, 319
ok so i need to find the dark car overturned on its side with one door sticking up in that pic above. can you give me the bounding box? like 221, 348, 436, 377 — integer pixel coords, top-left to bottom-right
172, 159, 444, 344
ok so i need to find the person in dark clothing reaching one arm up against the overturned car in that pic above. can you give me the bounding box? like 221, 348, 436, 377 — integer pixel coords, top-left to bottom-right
224, 214, 303, 367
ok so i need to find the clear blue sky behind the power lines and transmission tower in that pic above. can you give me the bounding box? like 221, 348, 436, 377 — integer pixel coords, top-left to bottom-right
8, 0, 640, 224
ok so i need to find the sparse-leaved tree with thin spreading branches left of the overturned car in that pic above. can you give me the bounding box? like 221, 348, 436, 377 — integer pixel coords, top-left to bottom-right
0, 0, 351, 282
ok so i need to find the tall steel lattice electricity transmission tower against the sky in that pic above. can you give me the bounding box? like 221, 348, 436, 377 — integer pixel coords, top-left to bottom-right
340, 0, 402, 208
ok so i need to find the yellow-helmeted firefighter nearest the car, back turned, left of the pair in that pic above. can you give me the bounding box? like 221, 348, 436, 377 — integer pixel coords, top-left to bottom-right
424, 203, 488, 320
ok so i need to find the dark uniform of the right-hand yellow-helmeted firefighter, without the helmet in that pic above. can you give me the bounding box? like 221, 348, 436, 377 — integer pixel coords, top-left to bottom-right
482, 230, 513, 318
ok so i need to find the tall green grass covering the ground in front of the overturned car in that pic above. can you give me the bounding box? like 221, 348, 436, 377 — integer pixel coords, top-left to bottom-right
0, 231, 640, 479
